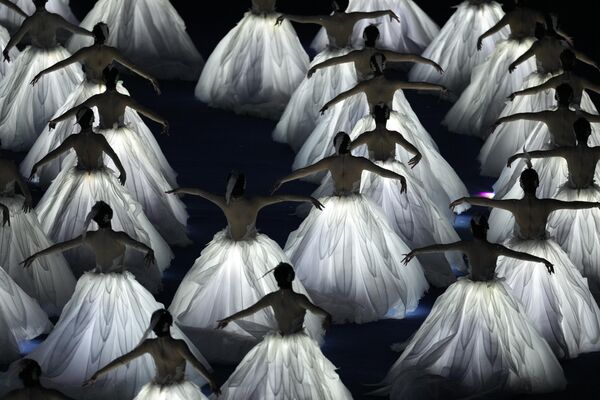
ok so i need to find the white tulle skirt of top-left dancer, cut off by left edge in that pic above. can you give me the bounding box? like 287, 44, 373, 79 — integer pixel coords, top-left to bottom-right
0, 46, 83, 151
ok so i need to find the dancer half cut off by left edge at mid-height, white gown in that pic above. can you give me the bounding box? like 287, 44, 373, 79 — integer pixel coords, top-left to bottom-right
0, 143, 75, 317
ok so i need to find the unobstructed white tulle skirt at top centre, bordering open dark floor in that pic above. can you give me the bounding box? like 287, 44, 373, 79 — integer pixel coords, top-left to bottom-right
196, 12, 309, 120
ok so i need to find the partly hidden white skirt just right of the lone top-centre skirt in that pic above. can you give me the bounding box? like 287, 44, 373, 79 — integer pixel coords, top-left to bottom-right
273, 48, 357, 151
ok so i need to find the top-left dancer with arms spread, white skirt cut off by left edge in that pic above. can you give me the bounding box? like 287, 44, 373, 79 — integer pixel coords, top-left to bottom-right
0, 0, 92, 151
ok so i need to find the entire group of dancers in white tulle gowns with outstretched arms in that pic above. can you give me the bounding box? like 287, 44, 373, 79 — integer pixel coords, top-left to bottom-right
0, 0, 600, 400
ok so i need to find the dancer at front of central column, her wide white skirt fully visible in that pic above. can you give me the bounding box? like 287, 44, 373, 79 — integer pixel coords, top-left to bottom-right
275, 132, 428, 323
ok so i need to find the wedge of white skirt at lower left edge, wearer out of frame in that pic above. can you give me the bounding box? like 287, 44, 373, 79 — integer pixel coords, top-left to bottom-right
0, 268, 52, 364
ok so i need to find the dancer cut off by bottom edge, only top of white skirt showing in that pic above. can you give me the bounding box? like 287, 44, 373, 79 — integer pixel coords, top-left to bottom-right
86, 310, 221, 400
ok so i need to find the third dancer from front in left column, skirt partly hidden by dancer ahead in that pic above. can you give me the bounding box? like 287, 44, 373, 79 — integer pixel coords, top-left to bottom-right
31, 108, 173, 290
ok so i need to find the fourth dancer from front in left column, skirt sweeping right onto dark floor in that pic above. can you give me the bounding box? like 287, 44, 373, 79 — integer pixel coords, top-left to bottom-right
38, 67, 191, 246
